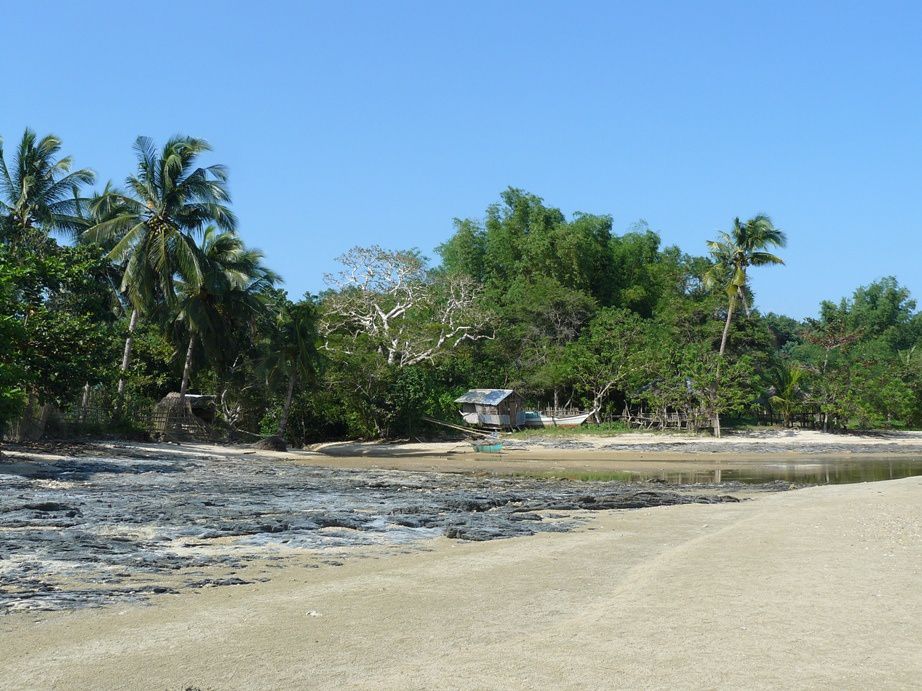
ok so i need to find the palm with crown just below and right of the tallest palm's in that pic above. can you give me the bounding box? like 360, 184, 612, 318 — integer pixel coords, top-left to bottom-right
175, 226, 279, 404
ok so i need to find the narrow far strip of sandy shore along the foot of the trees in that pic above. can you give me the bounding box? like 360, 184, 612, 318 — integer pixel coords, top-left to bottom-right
0, 430, 922, 477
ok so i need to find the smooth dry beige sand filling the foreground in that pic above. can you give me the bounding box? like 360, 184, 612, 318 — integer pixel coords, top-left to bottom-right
0, 478, 922, 689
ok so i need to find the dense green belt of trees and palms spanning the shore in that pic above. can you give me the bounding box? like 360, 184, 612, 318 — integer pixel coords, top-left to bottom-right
0, 131, 922, 443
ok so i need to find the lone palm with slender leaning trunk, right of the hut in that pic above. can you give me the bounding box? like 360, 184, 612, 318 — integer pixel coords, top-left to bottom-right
704, 214, 787, 437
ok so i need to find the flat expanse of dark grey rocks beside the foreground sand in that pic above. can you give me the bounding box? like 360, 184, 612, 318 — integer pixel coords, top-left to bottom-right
0, 448, 752, 613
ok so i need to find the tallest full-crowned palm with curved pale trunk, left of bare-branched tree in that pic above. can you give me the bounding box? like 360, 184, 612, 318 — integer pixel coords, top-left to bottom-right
83, 136, 237, 407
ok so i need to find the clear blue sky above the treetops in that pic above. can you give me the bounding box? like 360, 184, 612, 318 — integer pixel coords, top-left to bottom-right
0, 0, 922, 317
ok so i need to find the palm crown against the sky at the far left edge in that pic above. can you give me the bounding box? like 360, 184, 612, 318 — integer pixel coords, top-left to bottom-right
0, 129, 96, 247
